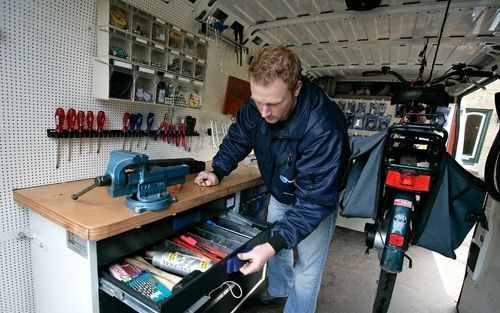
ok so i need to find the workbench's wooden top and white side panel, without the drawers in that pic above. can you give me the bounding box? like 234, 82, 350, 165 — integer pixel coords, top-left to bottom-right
14, 164, 262, 313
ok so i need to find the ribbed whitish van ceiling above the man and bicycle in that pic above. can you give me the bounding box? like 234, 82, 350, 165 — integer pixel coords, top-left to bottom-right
195, 0, 500, 88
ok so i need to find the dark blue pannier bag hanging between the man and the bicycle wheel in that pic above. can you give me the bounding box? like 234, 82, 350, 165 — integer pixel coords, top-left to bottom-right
339, 132, 387, 219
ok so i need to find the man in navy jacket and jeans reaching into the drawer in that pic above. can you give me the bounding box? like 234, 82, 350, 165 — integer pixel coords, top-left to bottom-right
195, 46, 349, 313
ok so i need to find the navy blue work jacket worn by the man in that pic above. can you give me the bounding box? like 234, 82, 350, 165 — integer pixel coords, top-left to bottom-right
212, 79, 349, 250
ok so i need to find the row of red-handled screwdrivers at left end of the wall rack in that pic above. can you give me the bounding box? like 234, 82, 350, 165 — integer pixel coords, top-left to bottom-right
54, 108, 106, 168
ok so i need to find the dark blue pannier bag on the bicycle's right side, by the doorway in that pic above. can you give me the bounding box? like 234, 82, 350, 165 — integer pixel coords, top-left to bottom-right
413, 153, 486, 259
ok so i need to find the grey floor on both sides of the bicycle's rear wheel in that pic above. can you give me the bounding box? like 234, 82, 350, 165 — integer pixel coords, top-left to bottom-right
237, 227, 468, 313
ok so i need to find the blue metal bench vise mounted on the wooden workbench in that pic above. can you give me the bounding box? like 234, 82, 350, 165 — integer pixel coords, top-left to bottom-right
71, 150, 189, 213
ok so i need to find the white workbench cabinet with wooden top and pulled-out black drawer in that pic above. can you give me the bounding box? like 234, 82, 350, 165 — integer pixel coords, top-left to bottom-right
14, 165, 267, 313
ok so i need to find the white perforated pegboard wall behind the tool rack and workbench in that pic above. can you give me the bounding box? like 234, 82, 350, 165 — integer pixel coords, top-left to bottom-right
0, 0, 246, 313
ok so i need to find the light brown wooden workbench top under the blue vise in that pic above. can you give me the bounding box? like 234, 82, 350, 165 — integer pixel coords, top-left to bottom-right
14, 164, 262, 240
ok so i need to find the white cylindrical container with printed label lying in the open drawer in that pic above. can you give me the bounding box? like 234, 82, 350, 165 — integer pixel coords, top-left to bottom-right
152, 251, 214, 276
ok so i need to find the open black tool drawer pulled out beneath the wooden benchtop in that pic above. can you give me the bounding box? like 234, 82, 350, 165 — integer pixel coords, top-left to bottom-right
97, 196, 269, 313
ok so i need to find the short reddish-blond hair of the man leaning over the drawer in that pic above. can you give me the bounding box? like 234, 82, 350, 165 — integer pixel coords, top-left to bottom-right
248, 46, 302, 90
